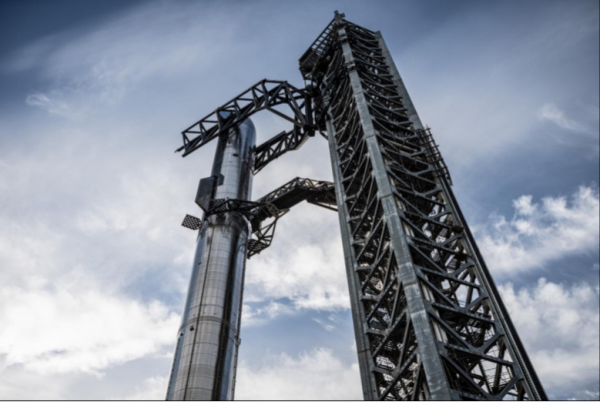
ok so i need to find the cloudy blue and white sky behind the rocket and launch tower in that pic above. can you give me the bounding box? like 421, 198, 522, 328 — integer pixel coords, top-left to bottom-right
0, 0, 600, 399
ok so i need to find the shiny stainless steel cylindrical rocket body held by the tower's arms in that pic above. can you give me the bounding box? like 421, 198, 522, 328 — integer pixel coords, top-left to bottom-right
167, 120, 256, 400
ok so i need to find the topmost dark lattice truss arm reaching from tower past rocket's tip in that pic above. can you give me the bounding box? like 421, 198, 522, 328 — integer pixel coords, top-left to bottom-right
176, 79, 315, 158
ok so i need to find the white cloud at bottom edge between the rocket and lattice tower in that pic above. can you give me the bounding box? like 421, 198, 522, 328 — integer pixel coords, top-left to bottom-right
235, 349, 362, 400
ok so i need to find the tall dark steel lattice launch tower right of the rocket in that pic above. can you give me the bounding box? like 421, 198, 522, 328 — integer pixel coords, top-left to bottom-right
308, 14, 546, 400
